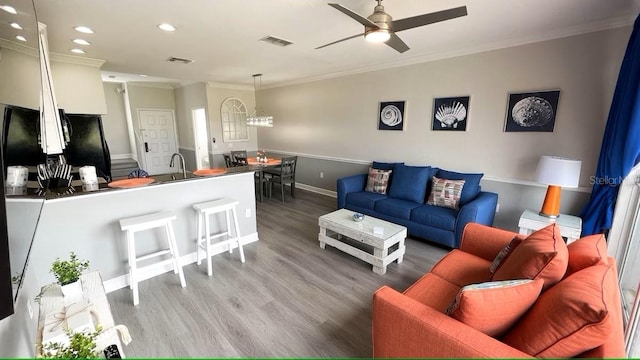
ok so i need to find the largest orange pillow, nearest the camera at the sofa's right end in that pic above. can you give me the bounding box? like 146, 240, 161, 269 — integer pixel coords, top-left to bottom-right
502, 264, 620, 358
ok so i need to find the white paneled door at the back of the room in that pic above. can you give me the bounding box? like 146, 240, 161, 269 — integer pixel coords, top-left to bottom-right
138, 110, 179, 175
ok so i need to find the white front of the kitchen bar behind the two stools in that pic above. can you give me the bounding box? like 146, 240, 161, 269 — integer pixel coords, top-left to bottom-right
7, 172, 258, 296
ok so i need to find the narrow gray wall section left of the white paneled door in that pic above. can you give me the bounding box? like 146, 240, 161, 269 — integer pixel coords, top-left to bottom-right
102, 82, 133, 158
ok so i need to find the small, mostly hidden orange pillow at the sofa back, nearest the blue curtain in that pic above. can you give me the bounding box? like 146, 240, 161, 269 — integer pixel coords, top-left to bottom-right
565, 234, 608, 276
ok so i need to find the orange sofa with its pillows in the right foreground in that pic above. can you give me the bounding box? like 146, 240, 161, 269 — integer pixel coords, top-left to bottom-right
373, 223, 625, 358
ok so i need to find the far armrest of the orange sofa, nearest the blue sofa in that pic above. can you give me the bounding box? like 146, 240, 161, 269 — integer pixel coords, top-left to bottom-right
460, 223, 525, 261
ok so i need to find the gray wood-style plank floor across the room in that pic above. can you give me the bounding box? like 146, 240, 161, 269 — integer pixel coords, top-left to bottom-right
108, 190, 448, 357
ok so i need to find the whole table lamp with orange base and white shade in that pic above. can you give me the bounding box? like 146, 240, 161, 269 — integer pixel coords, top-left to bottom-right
536, 156, 582, 219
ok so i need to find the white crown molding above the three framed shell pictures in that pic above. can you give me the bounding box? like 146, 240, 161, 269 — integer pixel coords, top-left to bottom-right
262, 15, 636, 89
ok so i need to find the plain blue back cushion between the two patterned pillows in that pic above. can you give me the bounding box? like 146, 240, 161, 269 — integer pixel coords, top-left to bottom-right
388, 164, 435, 203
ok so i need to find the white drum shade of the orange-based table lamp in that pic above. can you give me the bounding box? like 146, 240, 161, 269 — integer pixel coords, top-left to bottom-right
536, 156, 582, 187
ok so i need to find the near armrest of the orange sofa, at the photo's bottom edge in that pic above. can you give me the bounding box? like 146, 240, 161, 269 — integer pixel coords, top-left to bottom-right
373, 286, 531, 358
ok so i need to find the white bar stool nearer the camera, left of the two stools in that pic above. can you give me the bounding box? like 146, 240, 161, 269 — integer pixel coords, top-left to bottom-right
120, 211, 187, 305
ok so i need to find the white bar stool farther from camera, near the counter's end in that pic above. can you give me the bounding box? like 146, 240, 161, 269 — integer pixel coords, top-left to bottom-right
193, 199, 244, 276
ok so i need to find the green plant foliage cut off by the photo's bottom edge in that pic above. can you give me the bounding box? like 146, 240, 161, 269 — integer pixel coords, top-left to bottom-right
42, 327, 101, 359
